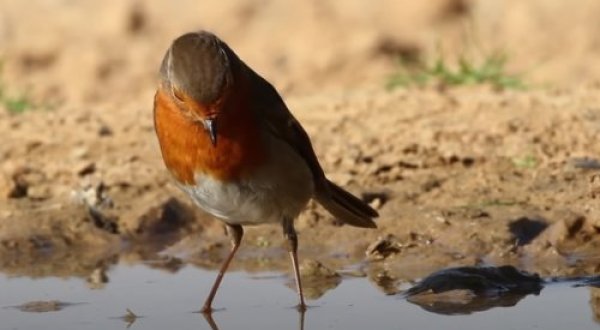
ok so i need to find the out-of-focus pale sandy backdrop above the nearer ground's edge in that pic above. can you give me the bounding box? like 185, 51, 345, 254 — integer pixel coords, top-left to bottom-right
0, 0, 600, 105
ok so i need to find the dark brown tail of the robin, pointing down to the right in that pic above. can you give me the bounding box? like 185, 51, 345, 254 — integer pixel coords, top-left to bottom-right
316, 179, 379, 228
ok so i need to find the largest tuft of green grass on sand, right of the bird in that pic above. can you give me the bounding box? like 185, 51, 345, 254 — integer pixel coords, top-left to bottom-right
387, 52, 527, 89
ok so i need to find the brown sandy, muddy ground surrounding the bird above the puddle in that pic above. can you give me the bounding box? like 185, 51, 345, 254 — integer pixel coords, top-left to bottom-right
0, 0, 600, 291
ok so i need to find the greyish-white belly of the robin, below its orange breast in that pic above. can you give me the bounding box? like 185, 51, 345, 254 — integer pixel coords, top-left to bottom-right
182, 139, 314, 225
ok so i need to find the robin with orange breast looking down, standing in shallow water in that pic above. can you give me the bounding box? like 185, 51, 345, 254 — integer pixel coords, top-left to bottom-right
154, 31, 378, 313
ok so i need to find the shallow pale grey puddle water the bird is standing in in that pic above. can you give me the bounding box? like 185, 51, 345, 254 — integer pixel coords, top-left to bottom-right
0, 265, 598, 330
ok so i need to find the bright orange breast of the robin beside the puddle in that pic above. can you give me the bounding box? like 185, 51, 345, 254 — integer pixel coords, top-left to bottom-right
154, 88, 265, 184
